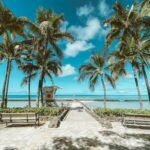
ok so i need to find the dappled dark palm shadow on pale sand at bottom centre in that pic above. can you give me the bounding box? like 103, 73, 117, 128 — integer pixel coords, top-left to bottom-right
52, 137, 129, 150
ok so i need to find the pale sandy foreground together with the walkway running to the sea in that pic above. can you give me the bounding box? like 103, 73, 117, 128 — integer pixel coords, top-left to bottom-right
0, 102, 150, 150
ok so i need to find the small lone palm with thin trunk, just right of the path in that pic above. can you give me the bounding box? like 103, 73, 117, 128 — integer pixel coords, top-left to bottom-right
79, 54, 115, 109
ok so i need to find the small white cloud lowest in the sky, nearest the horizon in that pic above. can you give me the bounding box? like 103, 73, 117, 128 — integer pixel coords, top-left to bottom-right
59, 64, 75, 77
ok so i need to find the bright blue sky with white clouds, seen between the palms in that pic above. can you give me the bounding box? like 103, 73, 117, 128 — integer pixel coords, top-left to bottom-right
0, 0, 150, 95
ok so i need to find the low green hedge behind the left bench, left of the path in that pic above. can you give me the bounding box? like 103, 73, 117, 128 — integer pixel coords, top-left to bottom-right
0, 107, 63, 116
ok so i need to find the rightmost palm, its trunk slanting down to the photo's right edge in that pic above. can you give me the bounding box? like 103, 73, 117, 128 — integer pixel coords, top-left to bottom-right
120, 33, 150, 101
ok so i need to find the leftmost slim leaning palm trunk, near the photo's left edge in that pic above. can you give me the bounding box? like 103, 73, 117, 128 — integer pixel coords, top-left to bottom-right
2, 59, 10, 107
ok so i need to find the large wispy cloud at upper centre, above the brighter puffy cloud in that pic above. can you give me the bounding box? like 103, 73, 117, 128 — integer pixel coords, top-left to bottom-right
69, 17, 101, 40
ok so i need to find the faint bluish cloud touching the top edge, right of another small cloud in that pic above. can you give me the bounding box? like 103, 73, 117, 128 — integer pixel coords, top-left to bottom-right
98, 0, 112, 17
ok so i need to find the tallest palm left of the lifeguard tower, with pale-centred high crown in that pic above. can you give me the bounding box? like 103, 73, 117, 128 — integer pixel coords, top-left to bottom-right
29, 8, 72, 105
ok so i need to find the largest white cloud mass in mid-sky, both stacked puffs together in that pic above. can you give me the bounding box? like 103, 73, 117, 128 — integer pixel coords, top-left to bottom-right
64, 17, 107, 57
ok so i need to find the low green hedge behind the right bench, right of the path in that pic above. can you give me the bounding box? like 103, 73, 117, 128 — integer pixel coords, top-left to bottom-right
94, 108, 150, 117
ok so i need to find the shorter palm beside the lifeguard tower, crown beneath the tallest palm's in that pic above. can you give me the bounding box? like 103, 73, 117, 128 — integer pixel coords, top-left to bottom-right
33, 47, 61, 107
